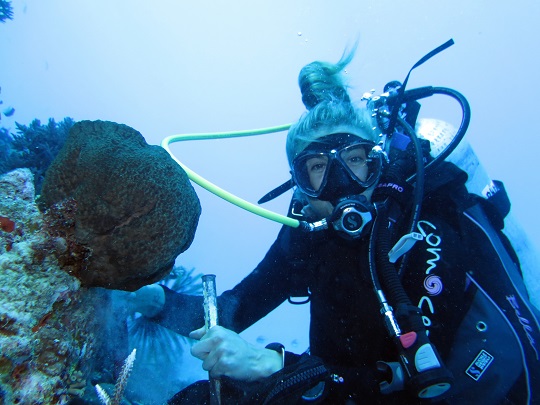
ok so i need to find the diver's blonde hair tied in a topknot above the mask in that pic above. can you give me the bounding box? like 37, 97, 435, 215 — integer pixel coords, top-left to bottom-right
286, 46, 376, 167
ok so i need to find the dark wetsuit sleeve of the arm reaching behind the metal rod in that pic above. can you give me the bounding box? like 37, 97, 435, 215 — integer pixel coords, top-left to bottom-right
152, 227, 298, 335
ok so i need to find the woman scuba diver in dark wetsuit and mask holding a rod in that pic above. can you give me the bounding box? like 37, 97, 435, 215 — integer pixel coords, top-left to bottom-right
130, 42, 540, 404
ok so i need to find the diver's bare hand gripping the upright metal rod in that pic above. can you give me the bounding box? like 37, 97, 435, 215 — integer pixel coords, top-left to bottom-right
189, 326, 282, 381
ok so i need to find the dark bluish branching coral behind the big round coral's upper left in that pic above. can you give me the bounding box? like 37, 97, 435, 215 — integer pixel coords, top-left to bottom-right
0, 117, 74, 194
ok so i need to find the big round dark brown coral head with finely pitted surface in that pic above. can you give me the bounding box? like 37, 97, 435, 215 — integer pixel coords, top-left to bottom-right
39, 121, 201, 291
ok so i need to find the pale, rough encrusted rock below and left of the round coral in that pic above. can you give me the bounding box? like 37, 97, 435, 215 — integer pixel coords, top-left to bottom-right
0, 169, 107, 404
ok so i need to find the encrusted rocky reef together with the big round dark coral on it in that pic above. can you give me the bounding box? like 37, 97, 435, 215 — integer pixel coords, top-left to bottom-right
0, 121, 201, 405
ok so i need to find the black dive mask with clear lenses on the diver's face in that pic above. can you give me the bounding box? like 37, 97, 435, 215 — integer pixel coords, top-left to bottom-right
292, 134, 383, 201
